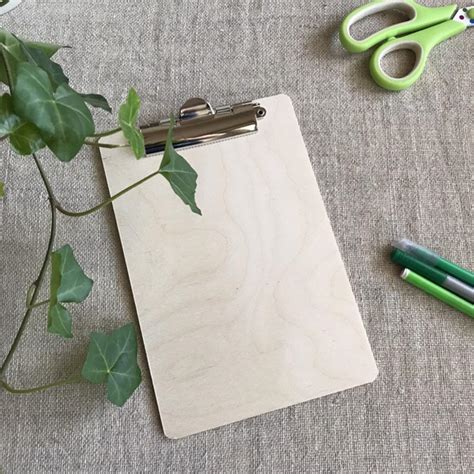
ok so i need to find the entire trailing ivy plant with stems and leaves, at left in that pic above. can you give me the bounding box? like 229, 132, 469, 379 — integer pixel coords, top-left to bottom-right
0, 28, 201, 406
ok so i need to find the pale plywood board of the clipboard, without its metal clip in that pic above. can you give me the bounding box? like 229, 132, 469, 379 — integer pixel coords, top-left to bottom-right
103, 95, 377, 438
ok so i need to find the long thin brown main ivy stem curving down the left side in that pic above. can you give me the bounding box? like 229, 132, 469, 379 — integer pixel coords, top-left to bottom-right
0, 153, 57, 376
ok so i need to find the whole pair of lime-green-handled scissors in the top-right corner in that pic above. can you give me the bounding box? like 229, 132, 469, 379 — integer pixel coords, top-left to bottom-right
339, 0, 474, 91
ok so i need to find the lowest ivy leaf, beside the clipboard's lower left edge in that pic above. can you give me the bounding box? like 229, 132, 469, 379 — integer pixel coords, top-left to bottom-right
82, 323, 142, 406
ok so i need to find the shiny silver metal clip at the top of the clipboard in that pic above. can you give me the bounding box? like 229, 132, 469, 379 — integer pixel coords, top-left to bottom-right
142, 98, 266, 155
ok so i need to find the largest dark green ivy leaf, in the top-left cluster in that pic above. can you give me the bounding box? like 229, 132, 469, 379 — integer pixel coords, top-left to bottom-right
13, 63, 94, 161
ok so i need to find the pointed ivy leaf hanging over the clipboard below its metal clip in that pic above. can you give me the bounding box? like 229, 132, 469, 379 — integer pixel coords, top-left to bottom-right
159, 117, 201, 215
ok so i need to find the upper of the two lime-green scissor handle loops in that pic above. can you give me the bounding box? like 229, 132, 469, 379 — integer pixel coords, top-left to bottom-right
339, 0, 457, 53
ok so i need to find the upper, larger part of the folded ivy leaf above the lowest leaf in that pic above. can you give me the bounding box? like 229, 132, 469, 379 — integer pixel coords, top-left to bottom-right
50, 244, 93, 304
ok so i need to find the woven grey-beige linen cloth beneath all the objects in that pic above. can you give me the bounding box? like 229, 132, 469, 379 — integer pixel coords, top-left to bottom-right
0, 0, 474, 473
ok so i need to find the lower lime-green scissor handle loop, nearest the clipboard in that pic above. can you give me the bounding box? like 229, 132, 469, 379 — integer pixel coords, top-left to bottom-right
370, 20, 467, 91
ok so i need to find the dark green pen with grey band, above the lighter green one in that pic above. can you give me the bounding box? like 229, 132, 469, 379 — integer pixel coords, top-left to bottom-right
391, 249, 474, 303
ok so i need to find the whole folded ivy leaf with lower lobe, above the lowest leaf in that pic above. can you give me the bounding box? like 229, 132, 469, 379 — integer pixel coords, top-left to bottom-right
48, 245, 93, 337
